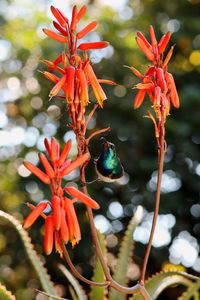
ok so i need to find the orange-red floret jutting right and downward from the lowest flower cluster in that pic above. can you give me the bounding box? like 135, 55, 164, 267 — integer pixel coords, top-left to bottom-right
64, 186, 99, 209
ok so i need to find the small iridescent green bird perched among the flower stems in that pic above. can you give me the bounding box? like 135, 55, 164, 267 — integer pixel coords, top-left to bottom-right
95, 137, 124, 182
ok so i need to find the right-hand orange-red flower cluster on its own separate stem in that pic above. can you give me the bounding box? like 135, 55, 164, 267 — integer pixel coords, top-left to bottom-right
130, 26, 180, 121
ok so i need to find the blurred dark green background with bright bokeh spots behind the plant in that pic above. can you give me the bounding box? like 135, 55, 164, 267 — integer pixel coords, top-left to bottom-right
0, 0, 200, 300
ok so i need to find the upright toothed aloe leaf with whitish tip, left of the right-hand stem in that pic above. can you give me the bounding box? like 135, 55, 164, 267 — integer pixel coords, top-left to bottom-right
109, 206, 143, 300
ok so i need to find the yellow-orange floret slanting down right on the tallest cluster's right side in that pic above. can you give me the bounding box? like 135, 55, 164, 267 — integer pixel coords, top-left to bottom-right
85, 64, 107, 107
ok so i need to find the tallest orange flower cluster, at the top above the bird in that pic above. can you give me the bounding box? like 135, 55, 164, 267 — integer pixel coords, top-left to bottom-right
43, 6, 114, 109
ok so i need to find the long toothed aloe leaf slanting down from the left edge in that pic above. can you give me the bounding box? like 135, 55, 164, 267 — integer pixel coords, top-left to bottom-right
0, 210, 58, 299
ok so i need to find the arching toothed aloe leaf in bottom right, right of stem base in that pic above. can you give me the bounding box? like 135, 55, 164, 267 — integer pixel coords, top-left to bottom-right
133, 271, 193, 300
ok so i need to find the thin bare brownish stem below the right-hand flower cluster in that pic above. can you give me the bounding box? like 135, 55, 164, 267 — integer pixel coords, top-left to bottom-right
139, 124, 166, 285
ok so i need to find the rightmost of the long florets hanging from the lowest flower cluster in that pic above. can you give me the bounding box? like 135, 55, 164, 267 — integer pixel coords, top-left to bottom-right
64, 197, 81, 246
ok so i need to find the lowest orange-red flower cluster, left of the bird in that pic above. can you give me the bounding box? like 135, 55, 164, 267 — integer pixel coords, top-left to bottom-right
24, 138, 99, 256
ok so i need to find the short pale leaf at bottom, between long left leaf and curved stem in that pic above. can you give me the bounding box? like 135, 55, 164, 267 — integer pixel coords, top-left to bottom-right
58, 264, 87, 300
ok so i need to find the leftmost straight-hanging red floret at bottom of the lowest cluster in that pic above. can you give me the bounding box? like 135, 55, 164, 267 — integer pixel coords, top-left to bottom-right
44, 216, 54, 255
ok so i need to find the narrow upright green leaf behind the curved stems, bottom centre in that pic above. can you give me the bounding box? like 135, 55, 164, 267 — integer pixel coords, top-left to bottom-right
90, 230, 108, 300
